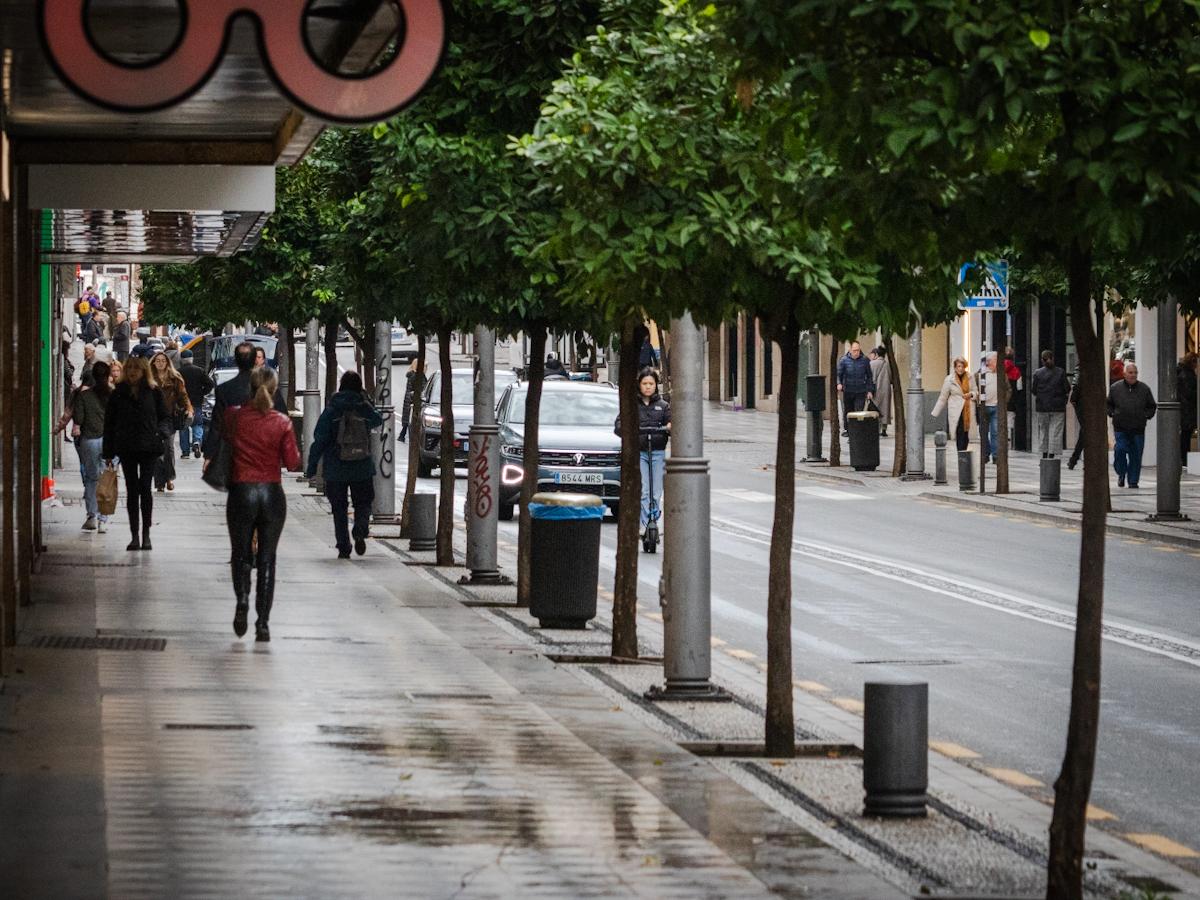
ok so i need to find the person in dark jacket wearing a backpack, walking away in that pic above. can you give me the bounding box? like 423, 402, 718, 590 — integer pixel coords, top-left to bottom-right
305, 372, 383, 559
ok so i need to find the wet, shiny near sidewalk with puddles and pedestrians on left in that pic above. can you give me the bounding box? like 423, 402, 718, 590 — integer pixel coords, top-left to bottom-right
0, 446, 901, 899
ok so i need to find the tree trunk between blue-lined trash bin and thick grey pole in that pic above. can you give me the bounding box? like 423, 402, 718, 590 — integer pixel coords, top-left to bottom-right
612, 318, 646, 659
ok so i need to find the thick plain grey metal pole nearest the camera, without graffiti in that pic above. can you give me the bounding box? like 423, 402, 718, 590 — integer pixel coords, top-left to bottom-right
646, 313, 730, 700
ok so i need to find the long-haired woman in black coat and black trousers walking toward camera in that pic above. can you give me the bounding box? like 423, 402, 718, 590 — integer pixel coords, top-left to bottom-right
104, 356, 170, 550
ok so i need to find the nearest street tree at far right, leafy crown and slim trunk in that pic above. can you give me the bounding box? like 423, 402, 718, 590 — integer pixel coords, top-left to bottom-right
738, 0, 1200, 898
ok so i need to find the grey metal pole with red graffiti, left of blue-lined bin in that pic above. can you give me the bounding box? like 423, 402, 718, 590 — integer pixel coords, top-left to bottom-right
461, 325, 510, 584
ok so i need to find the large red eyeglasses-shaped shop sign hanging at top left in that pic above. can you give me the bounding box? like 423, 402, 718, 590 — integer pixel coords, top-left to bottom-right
38, 0, 445, 125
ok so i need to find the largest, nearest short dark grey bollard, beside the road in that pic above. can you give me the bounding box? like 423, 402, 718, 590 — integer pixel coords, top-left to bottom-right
863, 682, 929, 817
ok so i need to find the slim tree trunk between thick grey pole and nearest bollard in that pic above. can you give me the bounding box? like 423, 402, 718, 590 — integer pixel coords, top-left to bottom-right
766, 311, 800, 757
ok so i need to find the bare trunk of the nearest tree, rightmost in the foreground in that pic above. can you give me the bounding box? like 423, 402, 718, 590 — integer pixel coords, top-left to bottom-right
1046, 242, 1109, 900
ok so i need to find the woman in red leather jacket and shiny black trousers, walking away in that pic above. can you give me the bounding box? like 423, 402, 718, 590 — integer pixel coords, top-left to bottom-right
224, 366, 300, 641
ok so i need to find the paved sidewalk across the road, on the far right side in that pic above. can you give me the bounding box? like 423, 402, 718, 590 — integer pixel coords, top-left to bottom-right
704, 403, 1200, 550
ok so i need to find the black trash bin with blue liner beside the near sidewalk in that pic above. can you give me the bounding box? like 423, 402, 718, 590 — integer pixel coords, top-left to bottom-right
529, 493, 604, 629
